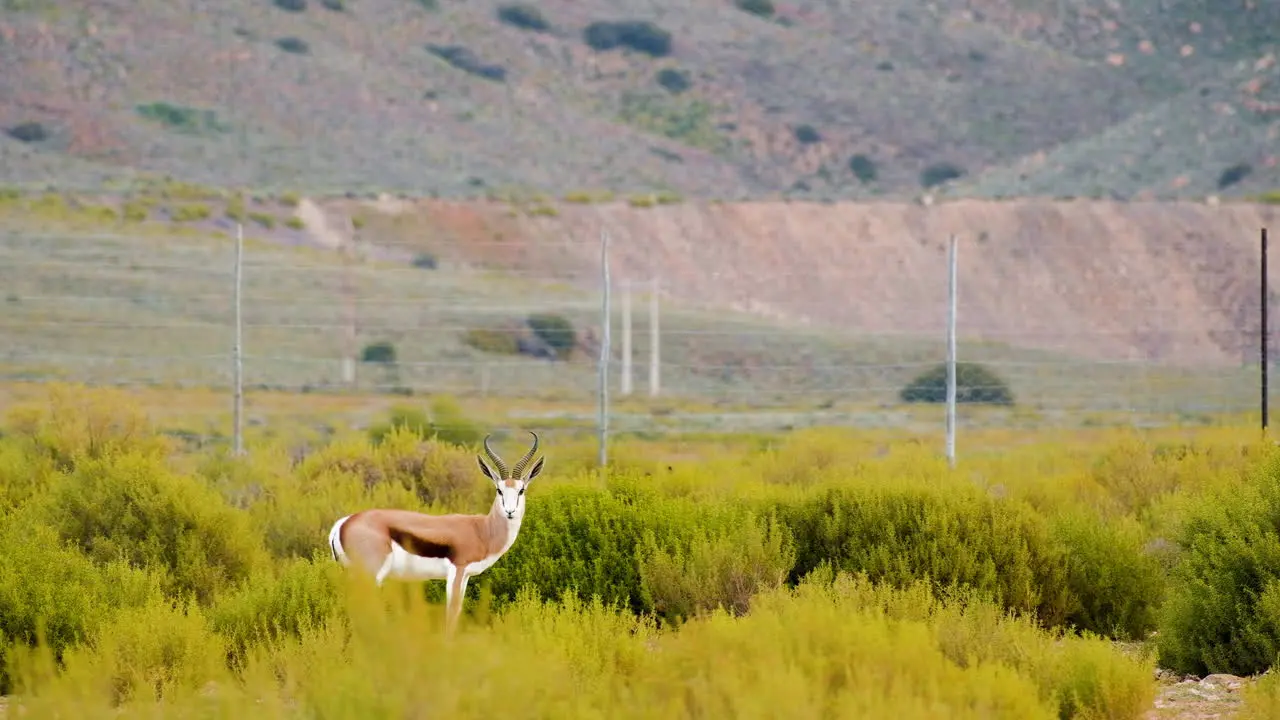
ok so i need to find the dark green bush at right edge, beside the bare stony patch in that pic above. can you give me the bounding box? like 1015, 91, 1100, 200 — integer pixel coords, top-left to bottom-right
1158, 460, 1280, 675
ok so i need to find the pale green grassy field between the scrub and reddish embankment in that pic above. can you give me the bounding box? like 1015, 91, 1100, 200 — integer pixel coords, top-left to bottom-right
0, 196, 1257, 430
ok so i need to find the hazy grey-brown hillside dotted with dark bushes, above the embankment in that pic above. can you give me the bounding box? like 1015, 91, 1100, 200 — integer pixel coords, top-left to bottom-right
0, 0, 1280, 200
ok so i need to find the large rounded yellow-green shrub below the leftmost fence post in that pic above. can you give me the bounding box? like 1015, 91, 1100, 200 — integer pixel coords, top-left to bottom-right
49, 455, 265, 603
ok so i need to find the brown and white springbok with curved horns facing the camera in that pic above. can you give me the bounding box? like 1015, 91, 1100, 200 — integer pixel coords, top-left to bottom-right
329, 430, 547, 633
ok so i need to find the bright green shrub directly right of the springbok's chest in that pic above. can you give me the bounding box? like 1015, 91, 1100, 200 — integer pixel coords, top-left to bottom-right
485, 475, 773, 620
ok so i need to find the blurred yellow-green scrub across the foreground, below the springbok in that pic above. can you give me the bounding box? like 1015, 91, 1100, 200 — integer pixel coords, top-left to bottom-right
5, 566, 1153, 720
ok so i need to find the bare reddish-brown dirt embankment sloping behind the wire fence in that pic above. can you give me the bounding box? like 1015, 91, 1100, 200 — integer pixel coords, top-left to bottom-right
335, 200, 1280, 364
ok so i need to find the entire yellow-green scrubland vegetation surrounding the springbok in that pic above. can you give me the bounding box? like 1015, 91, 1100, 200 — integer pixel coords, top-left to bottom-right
0, 386, 1280, 719
